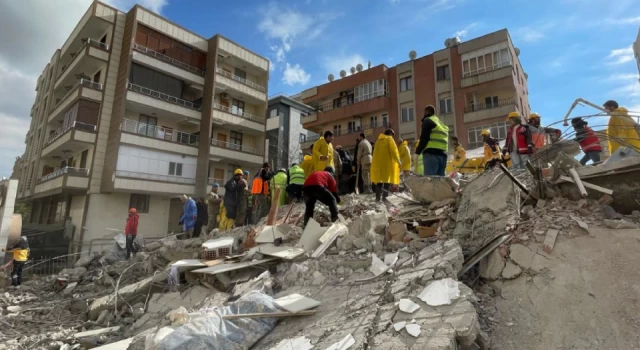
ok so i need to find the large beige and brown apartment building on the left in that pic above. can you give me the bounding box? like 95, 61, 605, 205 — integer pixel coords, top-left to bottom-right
13, 1, 269, 250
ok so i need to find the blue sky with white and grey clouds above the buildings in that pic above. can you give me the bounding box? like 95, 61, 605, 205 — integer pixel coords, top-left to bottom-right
0, 0, 640, 176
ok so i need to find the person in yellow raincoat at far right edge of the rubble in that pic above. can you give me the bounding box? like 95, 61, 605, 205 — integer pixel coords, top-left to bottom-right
603, 100, 640, 154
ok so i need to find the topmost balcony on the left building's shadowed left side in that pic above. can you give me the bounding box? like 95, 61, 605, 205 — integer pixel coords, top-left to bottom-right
54, 38, 109, 90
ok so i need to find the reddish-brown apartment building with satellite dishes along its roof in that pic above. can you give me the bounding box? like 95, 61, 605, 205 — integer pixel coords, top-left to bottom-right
301, 29, 531, 155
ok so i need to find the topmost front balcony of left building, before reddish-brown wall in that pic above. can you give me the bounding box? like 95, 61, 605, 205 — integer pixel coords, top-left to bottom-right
132, 43, 204, 89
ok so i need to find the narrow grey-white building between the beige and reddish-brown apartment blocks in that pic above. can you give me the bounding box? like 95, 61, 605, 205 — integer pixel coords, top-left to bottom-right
266, 94, 316, 169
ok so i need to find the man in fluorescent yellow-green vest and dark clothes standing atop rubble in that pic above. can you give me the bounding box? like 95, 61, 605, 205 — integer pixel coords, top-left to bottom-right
416, 105, 449, 176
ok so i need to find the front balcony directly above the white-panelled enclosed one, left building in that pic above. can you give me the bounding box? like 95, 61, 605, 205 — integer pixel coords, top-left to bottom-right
120, 119, 200, 156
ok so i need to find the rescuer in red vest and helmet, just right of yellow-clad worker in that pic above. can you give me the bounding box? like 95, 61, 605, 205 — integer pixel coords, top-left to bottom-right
502, 112, 534, 169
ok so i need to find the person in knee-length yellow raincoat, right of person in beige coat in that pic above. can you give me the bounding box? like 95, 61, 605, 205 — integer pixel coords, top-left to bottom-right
371, 129, 402, 202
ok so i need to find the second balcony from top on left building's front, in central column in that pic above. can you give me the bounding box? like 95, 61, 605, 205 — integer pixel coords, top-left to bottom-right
127, 83, 201, 124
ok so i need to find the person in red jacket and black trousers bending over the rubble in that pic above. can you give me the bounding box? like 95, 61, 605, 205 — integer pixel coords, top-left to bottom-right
302, 167, 340, 227
